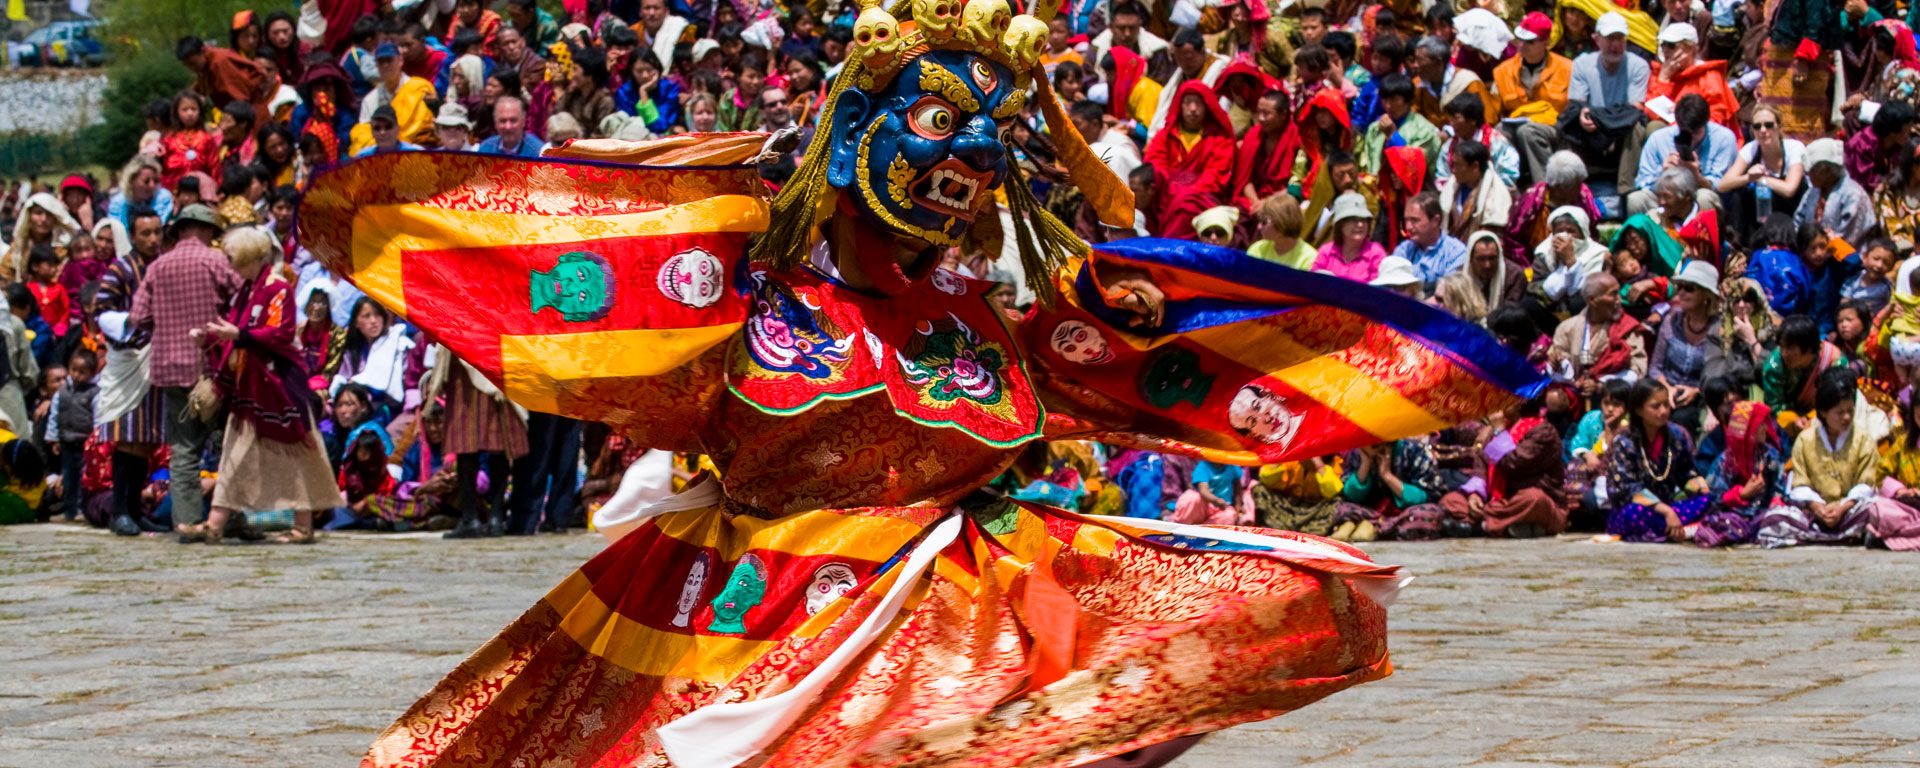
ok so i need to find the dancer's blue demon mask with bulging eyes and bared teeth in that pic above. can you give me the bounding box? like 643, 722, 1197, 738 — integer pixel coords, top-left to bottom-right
828, 50, 1025, 246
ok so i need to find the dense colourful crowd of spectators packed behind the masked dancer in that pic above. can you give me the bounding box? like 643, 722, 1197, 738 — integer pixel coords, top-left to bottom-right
0, 0, 1920, 549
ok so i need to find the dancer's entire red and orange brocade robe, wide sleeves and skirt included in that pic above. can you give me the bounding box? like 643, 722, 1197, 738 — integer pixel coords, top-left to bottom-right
301, 136, 1540, 766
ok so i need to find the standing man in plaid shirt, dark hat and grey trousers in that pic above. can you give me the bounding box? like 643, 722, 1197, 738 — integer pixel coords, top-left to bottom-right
129, 204, 242, 543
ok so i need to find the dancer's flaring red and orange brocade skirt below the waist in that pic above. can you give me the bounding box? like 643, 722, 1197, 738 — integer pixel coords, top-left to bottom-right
363, 476, 1402, 768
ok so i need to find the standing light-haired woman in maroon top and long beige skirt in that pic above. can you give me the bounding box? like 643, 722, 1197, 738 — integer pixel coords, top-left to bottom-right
181, 228, 346, 543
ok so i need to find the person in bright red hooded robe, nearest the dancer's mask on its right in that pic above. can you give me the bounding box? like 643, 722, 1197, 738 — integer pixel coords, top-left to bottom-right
1146, 81, 1235, 240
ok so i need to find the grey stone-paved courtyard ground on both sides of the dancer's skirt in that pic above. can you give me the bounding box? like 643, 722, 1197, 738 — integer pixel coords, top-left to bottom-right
0, 526, 1920, 768
